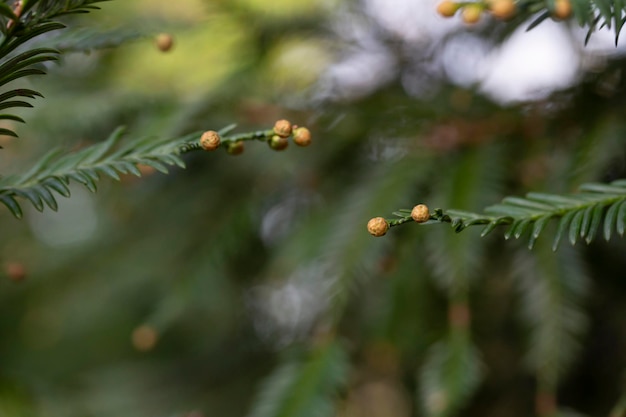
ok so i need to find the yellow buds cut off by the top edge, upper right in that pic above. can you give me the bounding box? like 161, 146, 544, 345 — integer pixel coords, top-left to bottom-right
437, 0, 572, 24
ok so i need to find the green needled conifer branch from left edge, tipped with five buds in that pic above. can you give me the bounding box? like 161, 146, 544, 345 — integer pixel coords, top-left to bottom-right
0, 121, 308, 218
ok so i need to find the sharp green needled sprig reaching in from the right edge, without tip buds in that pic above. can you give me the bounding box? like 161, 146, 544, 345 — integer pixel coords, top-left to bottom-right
376, 179, 626, 250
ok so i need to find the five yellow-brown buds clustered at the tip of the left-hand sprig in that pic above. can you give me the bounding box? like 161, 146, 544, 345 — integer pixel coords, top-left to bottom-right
200, 119, 311, 155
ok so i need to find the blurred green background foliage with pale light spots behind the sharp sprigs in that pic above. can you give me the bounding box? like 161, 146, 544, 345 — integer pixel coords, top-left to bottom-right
0, 0, 626, 417
